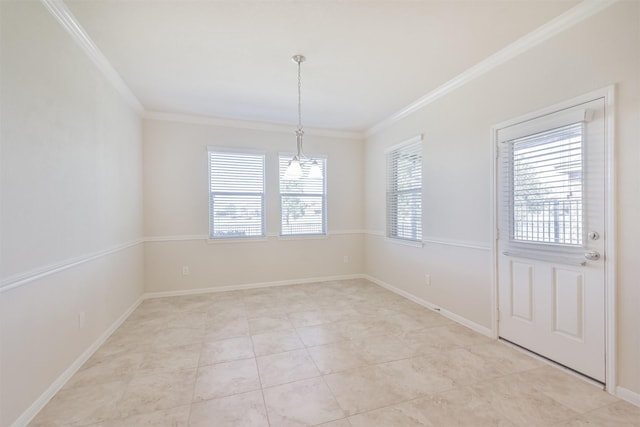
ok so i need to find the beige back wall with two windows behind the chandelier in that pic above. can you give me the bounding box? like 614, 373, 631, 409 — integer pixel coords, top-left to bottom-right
143, 120, 364, 292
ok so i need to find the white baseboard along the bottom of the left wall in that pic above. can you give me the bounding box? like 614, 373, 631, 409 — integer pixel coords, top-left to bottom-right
11, 297, 143, 427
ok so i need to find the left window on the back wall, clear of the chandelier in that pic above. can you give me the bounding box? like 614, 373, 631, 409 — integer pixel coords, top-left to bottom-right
209, 151, 265, 239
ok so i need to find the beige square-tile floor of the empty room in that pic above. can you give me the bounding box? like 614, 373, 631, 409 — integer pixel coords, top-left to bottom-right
30, 280, 640, 427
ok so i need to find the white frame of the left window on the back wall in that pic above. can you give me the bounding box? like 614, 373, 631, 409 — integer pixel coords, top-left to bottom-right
207, 146, 267, 242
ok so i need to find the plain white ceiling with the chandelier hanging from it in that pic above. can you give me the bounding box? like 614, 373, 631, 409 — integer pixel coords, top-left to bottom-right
65, 0, 578, 132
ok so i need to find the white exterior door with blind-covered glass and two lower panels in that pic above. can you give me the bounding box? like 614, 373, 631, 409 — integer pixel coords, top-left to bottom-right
496, 98, 607, 383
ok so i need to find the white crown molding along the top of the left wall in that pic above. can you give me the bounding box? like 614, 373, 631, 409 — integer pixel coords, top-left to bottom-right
40, 0, 144, 114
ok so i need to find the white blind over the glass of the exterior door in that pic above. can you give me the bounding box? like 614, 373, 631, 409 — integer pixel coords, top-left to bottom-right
500, 122, 584, 246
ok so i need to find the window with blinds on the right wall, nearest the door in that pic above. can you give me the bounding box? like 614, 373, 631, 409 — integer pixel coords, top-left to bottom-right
387, 137, 422, 241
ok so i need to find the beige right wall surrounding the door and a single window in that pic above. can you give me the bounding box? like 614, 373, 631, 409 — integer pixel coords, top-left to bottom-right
365, 1, 640, 398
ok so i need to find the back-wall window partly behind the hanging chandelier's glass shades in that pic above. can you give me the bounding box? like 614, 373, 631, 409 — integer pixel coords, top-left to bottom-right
279, 155, 327, 236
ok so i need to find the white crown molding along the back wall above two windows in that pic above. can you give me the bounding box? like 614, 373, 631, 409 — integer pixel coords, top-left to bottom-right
142, 111, 364, 140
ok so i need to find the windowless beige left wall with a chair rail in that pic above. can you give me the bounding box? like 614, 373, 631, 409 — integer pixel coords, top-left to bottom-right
0, 1, 144, 426
